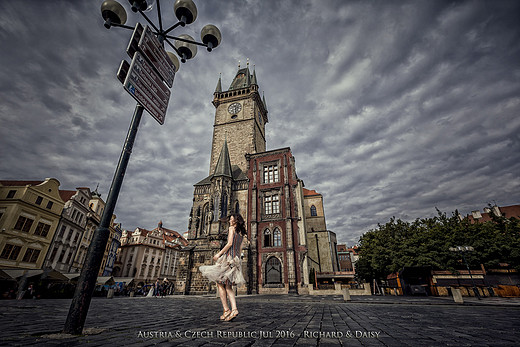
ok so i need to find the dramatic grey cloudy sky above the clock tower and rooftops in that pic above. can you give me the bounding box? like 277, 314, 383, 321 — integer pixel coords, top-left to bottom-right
0, 0, 520, 245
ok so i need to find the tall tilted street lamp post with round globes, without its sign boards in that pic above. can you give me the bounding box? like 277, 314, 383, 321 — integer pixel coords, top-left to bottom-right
63, 0, 221, 335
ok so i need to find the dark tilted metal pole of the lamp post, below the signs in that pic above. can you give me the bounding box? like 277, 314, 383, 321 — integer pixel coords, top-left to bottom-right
63, 104, 144, 335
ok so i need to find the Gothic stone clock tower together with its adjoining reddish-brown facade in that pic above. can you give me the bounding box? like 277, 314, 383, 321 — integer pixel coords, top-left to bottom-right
176, 66, 330, 294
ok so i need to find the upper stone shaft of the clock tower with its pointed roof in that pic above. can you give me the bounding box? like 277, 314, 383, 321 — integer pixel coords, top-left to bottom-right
209, 66, 268, 174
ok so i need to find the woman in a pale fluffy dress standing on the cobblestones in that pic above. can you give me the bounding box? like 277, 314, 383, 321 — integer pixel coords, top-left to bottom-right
199, 213, 247, 321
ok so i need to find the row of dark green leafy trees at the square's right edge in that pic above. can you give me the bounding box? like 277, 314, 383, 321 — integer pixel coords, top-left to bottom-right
356, 210, 520, 280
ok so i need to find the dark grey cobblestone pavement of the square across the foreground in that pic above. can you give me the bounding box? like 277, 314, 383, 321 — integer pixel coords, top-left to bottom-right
0, 295, 520, 347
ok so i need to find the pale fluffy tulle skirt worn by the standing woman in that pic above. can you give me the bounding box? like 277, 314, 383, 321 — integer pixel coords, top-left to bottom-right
199, 254, 246, 285
